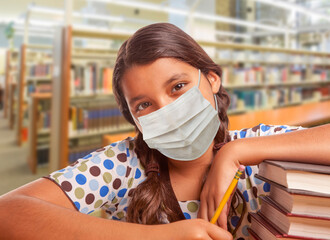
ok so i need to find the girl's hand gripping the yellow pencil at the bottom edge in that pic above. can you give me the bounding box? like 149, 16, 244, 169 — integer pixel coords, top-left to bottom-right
155, 219, 233, 240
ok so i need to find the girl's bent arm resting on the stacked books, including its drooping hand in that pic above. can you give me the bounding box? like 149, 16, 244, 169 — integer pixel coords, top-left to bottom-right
199, 124, 330, 229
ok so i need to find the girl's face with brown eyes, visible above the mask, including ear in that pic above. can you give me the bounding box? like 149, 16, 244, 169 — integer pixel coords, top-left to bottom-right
122, 58, 221, 127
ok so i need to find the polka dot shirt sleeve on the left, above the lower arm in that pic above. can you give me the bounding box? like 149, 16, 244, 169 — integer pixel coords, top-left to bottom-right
45, 137, 143, 214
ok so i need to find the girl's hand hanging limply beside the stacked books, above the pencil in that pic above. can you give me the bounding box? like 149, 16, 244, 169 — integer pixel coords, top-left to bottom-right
198, 142, 240, 230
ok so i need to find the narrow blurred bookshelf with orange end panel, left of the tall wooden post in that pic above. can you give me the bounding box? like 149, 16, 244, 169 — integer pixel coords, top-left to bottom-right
15, 44, 53, 146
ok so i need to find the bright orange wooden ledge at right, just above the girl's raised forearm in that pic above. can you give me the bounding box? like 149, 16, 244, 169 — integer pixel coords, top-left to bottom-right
229, 101, 330, 130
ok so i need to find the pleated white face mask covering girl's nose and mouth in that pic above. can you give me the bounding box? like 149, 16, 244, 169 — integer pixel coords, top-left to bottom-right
132, 70, 220, 161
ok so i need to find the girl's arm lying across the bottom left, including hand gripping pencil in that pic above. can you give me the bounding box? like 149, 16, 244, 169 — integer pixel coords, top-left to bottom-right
0, 179, 232, 240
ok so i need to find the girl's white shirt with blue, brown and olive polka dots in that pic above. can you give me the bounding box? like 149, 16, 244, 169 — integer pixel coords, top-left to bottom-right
46, 124, 303, 240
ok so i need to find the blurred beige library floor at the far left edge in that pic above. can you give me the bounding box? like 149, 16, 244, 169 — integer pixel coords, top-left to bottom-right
0, 111, 48, 195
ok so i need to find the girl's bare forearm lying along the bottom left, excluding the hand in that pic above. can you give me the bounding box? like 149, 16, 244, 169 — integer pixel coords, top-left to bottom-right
0, 195, 153, 239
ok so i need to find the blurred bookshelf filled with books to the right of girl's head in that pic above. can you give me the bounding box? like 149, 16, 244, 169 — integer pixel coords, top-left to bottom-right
208, 43, 330, 114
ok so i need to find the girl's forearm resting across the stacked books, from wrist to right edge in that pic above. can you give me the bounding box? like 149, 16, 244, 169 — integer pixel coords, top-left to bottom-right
228, 124, 330, 165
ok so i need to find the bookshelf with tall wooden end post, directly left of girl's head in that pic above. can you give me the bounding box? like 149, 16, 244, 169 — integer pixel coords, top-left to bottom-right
49, 27, 134, 171
